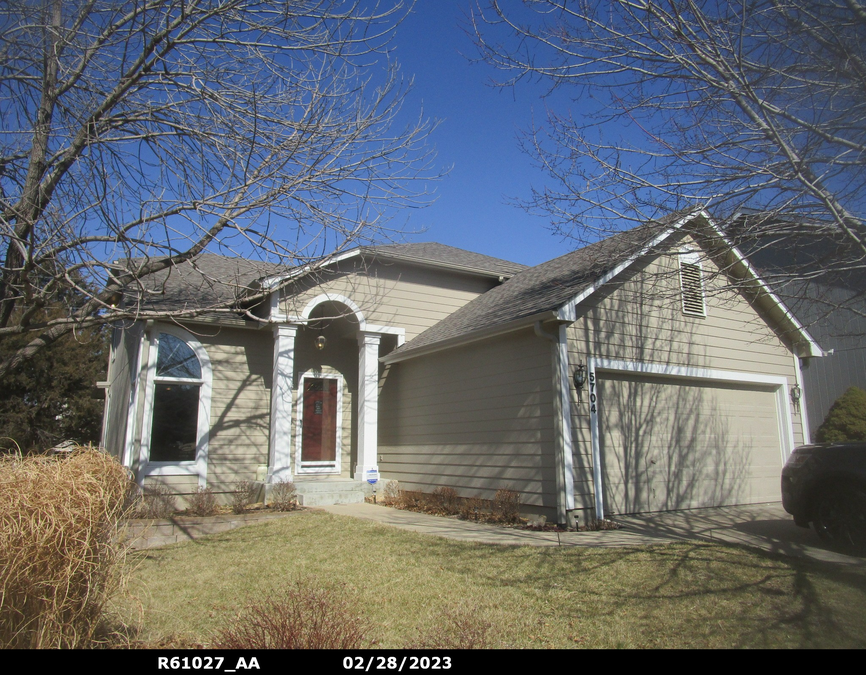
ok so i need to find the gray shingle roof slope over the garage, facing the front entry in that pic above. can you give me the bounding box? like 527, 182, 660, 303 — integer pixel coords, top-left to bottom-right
392, 219, 671, 355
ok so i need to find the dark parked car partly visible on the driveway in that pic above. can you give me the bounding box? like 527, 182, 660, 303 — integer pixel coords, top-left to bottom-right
782, 443, 866, 553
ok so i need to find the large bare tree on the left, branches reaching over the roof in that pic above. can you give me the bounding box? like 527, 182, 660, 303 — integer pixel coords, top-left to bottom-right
0, 0, 430, 377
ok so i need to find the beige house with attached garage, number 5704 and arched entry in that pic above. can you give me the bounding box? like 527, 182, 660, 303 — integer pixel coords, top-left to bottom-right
104, 212, 821, 522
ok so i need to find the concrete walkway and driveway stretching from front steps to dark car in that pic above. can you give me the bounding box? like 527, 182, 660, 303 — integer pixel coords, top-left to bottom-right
318, 504, 866, 566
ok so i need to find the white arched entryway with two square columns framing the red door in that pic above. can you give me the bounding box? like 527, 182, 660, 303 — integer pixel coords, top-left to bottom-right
269, 294, 403, 482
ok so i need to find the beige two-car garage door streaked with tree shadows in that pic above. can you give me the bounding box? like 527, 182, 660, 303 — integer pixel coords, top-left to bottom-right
598, 372, 782, 513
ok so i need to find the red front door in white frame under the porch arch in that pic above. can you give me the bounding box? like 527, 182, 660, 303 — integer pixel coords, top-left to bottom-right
300, 377, 339, 473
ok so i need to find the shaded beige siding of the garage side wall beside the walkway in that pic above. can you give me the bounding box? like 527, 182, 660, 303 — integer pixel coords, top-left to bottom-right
379, 330, 556, 508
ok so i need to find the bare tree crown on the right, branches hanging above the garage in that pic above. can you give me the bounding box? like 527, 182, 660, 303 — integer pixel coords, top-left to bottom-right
472, 0, 866, 302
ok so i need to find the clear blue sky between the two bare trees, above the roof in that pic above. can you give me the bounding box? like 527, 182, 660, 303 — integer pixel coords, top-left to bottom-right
384, 0, 575, 265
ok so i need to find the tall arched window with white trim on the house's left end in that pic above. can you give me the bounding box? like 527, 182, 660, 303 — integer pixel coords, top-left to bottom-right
141, 327, 211, 484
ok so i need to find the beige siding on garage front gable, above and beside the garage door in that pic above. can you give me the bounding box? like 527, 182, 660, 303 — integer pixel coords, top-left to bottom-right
568, 246, 803, 508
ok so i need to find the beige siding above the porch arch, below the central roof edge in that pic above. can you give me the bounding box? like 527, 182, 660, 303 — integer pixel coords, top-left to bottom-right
282, 261, 496, 341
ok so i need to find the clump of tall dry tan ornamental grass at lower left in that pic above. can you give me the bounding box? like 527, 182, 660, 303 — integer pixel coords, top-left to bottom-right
0, 448, 129, 648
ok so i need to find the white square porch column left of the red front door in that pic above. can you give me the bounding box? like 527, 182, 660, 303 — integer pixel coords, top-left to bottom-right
268, 324, 298, 483
